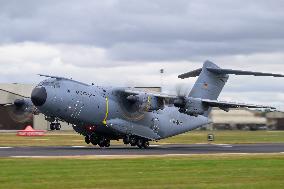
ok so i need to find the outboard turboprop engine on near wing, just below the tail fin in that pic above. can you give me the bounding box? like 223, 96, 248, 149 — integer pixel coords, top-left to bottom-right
174, 97, 208, 116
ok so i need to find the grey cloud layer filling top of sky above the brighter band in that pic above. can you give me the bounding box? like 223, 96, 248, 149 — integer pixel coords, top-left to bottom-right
0, 0, 284, 61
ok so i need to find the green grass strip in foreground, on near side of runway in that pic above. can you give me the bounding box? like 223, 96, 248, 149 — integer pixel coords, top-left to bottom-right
0, 155, 284, 189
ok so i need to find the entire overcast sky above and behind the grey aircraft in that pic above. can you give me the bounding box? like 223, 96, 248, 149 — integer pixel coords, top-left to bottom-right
0, 0, 284, 110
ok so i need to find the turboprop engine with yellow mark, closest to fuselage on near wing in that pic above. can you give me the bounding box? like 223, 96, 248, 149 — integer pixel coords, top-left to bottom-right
127, 94, 165, 112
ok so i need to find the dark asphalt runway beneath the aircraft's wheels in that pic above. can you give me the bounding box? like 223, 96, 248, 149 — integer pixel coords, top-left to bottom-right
0, 143, 284, 157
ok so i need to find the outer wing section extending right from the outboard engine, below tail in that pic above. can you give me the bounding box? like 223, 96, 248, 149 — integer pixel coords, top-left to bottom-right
201, 99, 276, 109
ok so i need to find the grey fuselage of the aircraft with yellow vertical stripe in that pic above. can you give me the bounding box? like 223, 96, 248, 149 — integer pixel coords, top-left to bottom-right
32, 78, 209, 140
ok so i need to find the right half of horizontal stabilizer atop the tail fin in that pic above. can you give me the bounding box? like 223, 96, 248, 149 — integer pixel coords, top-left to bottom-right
206, 68, 284, 77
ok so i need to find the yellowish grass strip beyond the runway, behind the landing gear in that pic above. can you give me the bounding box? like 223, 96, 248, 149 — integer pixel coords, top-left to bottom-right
0, 131, 284, 146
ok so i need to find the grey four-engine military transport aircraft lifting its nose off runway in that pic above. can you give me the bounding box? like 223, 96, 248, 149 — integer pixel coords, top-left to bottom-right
0, 61, 284, 148
